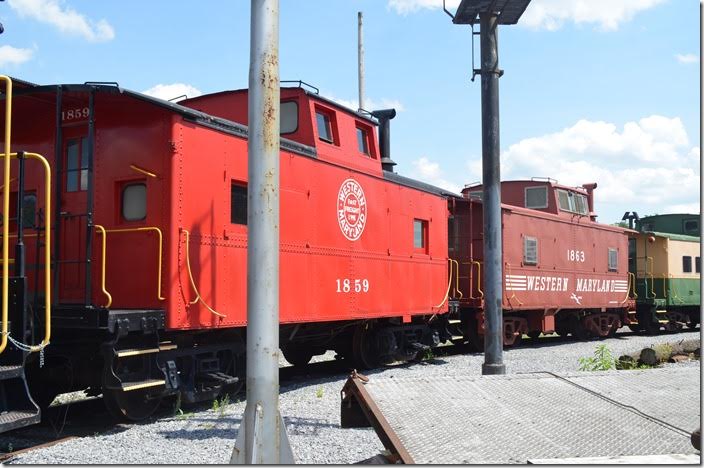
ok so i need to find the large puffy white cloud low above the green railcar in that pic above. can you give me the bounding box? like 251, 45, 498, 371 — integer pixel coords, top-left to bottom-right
502, 115, 700, 222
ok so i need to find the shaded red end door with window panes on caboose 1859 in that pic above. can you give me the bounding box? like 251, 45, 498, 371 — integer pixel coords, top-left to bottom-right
56, 103, 93, 304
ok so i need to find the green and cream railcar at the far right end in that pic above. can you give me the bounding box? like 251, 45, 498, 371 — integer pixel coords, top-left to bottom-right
629, 214, 701, 333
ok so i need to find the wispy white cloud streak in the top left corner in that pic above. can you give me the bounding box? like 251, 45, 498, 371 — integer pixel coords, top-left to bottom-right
9, 0, 115, 42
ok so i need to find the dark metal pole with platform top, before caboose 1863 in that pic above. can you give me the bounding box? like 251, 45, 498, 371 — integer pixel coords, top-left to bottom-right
443, 0, 530, 374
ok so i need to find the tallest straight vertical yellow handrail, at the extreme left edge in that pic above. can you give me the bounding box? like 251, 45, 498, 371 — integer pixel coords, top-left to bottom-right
0, 75, 11, 353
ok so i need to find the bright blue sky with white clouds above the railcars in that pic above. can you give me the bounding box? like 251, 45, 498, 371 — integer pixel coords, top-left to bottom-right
0, 0, 701, 223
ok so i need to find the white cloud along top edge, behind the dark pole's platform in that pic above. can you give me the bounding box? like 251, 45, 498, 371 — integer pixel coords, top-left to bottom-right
388, 0, 666, 31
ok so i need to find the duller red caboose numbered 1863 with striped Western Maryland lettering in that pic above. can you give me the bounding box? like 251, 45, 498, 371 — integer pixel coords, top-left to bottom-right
449, 179, 633, 347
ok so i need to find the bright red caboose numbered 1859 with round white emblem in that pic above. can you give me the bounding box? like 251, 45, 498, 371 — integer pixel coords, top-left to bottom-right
0, 83, 448, 419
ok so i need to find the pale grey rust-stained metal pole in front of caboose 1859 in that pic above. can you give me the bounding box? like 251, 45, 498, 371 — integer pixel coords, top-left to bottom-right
230, 0, 294, 464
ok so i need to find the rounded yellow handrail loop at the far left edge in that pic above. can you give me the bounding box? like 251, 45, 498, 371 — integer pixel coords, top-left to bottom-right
0, 152, 51, 353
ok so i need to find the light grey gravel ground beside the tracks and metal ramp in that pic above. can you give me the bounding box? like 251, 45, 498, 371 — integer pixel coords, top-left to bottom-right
5, 330, 700, 464
